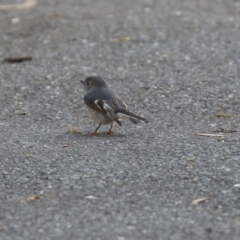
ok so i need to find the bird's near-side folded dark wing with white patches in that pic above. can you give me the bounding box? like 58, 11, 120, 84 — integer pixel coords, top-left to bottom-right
83, 95, 122, 126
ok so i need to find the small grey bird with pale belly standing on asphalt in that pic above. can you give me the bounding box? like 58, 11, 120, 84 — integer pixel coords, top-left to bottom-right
80, 76, 148, 135
